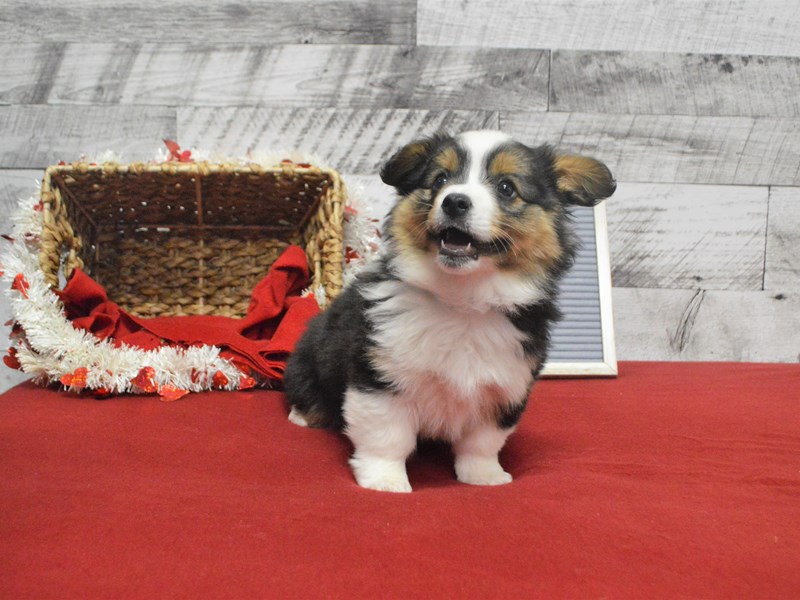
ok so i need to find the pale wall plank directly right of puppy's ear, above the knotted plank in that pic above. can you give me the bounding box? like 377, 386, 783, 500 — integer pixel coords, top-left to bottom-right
607, 183, 768, 290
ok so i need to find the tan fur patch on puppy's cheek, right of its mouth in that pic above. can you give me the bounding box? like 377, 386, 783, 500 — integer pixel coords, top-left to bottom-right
492, 206, 564, 275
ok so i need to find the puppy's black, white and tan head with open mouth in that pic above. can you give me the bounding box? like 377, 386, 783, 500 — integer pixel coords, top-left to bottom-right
381, 131, 616, 276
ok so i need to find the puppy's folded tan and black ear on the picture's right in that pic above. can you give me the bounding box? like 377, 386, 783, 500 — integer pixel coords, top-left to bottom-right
555, 154, 617, 206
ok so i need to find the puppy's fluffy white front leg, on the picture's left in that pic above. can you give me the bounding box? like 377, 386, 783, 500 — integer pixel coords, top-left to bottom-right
343, 388, 417, 492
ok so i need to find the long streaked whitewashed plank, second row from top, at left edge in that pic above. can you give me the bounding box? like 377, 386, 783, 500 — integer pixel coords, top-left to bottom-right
0, 43, 549, 110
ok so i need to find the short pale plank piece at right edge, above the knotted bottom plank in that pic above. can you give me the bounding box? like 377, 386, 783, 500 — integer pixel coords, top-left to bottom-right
764, 187, 800, 292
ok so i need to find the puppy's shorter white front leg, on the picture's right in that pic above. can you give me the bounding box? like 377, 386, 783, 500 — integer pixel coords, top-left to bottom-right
453, 423, 514, 485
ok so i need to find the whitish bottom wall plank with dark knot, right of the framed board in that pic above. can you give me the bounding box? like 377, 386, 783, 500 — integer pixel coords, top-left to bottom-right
613, 288, 800, 362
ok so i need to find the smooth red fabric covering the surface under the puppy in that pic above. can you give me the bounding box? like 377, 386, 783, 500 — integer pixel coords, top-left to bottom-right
0, 363, 800, 599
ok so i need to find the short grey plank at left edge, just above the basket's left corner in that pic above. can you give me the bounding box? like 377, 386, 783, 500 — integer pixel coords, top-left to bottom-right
0, 106, 176, 169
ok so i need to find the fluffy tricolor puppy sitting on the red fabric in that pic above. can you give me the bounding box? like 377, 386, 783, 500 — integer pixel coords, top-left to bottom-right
285, 131, 615, 492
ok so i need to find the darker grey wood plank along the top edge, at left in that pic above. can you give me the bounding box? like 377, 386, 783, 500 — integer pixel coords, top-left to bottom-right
0, 0, 416, 44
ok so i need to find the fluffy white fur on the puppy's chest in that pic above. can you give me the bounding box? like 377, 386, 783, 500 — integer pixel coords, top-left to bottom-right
365, 281, 532, 438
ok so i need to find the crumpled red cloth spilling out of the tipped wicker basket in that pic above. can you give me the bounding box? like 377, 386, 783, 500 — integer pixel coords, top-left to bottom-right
60, 246, 319, 379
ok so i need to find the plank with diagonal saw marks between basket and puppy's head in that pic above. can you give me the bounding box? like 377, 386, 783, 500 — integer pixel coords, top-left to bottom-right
178, 107, 498, 174
